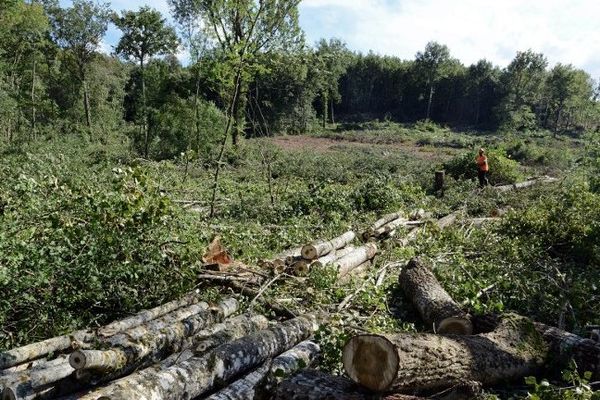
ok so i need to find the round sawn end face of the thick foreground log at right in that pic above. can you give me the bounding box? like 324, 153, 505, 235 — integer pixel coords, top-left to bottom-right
342, 335, 400, 392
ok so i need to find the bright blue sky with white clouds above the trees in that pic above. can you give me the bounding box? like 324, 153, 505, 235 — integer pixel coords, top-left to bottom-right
61, 0, 600, 79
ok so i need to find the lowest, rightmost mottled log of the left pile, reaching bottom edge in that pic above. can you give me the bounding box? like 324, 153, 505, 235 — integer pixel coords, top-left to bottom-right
207, 341, 320, 400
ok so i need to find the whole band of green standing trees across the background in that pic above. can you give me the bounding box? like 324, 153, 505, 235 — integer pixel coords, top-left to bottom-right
0, 0, 600, 158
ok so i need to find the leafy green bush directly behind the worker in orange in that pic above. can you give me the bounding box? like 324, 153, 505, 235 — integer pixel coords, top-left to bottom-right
444, 150, 523, 185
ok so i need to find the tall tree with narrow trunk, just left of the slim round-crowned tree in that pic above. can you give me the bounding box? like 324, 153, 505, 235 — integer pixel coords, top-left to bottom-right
50, 0, 110, 132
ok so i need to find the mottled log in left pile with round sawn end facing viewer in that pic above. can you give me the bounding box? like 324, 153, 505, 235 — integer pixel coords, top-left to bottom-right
69, 299, 238, 373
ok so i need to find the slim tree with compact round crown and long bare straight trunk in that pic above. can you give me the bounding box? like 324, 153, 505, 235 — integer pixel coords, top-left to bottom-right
113, 6, 179, 157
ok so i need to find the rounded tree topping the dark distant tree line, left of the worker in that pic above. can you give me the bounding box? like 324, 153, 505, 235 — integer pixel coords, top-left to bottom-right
415, 42, 452, 120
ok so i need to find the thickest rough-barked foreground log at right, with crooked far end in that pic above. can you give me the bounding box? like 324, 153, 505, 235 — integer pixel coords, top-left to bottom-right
343, 314, 548, 392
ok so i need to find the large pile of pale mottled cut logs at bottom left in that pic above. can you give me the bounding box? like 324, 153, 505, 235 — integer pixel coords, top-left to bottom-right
0, 293, 319, 400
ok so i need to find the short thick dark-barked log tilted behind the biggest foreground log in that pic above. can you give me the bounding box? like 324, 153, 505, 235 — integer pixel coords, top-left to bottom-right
398, 259, 473, 335
